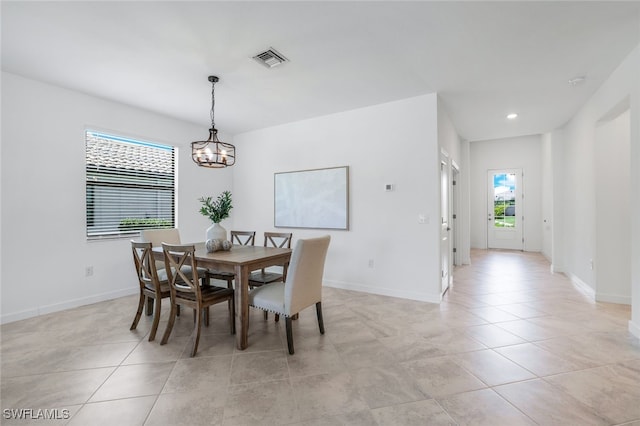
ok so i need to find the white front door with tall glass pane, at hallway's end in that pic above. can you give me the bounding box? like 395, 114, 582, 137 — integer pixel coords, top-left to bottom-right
487, 169, 524, 250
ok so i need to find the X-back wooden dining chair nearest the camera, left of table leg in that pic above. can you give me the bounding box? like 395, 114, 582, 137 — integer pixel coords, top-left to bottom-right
160, 243, 236, 357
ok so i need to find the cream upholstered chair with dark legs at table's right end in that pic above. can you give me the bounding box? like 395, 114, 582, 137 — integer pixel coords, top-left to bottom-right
249, 235, 331, 355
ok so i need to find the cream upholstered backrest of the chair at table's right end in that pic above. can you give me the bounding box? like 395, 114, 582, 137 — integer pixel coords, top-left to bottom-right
284, 235, 331, 315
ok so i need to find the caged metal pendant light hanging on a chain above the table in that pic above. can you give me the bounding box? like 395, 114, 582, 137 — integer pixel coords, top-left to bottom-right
191, 75, 236, 169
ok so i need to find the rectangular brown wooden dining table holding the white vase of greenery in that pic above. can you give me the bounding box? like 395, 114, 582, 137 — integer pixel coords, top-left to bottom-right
153, 243, 291, 350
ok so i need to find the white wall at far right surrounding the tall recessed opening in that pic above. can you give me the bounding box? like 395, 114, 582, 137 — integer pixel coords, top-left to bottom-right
558, 46, 640, 337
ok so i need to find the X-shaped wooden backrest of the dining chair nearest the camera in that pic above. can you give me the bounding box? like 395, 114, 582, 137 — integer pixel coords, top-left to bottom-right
162, 243, 200, 299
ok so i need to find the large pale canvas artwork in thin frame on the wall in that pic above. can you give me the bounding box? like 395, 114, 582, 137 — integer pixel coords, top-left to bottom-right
274, 166, 349, 229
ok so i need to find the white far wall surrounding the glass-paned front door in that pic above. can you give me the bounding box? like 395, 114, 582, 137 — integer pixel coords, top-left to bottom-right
470, 135, 543, 251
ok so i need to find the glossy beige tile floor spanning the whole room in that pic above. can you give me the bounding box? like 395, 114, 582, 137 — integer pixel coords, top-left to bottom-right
0, 251, 640, 426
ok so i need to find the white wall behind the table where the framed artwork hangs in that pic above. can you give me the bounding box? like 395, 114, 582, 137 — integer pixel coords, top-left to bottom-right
234, 94, 440, 302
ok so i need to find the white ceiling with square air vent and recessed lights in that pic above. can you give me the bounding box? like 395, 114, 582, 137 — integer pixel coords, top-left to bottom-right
1, 1, 640, 140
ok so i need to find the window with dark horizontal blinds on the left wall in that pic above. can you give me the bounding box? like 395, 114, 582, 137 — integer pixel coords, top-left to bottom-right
86, 131, 175, 239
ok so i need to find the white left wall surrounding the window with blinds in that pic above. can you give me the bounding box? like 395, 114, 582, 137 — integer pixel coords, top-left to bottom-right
1, 73, 233, 322
